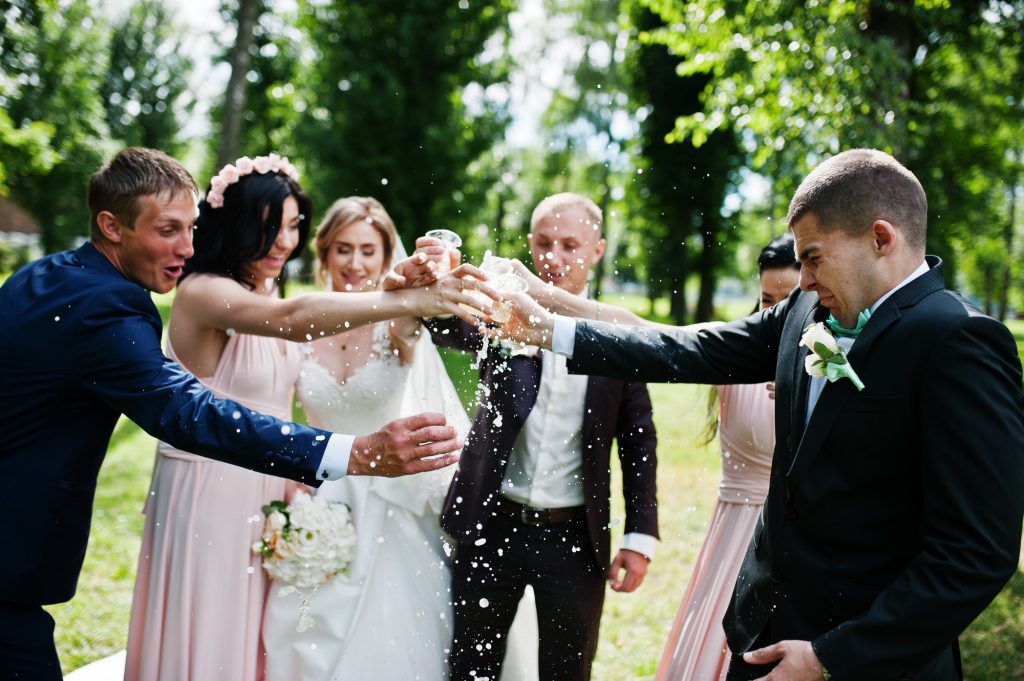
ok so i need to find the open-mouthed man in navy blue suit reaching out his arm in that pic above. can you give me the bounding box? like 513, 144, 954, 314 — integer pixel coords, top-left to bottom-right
0, 148, 459, 681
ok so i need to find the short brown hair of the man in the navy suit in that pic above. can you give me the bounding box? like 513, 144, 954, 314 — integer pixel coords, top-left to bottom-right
89, 146, 199, 239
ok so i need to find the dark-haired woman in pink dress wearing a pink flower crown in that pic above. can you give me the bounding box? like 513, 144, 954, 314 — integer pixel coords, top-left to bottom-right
119, 155, 495, 681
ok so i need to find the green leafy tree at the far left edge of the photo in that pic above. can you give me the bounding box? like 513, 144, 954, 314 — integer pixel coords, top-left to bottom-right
0, 0, 108, 251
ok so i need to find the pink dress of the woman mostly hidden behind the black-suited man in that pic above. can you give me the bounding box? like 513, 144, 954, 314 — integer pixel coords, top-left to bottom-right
654, 383, 775, 681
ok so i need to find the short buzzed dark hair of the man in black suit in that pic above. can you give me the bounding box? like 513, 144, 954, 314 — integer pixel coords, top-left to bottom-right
786, 148, 928, 252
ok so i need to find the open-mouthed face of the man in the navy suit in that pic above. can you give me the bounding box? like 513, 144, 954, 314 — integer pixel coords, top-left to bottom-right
115, 191, 198, 293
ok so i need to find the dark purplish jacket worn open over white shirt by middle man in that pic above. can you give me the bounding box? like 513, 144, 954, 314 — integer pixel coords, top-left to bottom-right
427, 318, 657, 567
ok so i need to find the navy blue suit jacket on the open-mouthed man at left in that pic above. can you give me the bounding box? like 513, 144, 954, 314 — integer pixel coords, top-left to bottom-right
0, 244, 330, 605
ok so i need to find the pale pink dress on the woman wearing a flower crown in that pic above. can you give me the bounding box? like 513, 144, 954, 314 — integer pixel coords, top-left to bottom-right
125, 334, 302, 681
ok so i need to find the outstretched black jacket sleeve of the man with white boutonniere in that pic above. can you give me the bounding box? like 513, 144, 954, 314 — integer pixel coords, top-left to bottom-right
568, 297, 795, 385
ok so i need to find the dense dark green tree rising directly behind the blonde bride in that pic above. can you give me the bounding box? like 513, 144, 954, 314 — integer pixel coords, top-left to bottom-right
297, 0, 512, 244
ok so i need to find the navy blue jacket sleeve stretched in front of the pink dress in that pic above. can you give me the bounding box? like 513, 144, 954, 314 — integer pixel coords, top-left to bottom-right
74, 289, 331, 485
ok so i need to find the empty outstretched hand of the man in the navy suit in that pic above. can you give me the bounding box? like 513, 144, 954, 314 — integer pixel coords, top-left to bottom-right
348, 413, 462, 477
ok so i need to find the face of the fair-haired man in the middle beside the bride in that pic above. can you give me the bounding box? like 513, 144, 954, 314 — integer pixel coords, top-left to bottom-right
529, 206, 605, 294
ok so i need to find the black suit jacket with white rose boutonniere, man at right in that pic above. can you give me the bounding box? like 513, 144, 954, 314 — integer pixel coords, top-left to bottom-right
570, 257, 1024, 681
